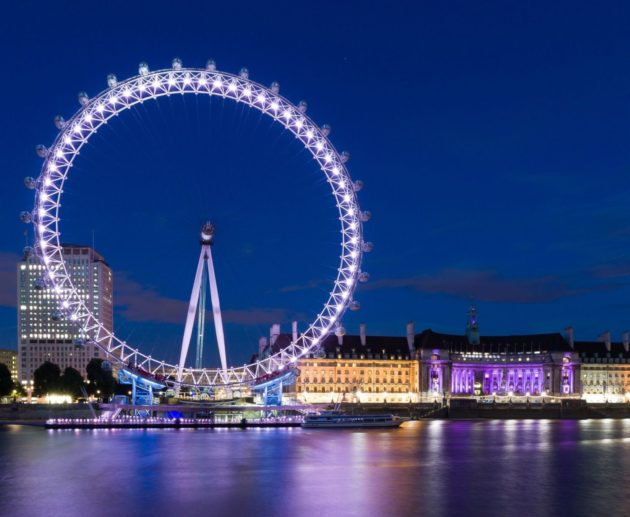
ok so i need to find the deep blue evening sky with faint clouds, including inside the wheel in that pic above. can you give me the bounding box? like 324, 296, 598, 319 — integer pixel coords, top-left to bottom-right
0, 1, 630, 363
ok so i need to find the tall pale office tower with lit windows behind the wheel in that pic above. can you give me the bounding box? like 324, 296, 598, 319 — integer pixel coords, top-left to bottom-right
18, 245, 113, 382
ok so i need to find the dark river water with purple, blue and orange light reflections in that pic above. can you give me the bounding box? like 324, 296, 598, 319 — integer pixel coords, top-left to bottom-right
0, 420, 630, 517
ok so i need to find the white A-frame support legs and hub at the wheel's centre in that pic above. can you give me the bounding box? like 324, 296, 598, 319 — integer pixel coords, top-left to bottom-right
177, 222, 227, 382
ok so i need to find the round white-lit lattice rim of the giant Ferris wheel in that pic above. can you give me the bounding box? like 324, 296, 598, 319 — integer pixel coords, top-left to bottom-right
32, 62, 364, 387
